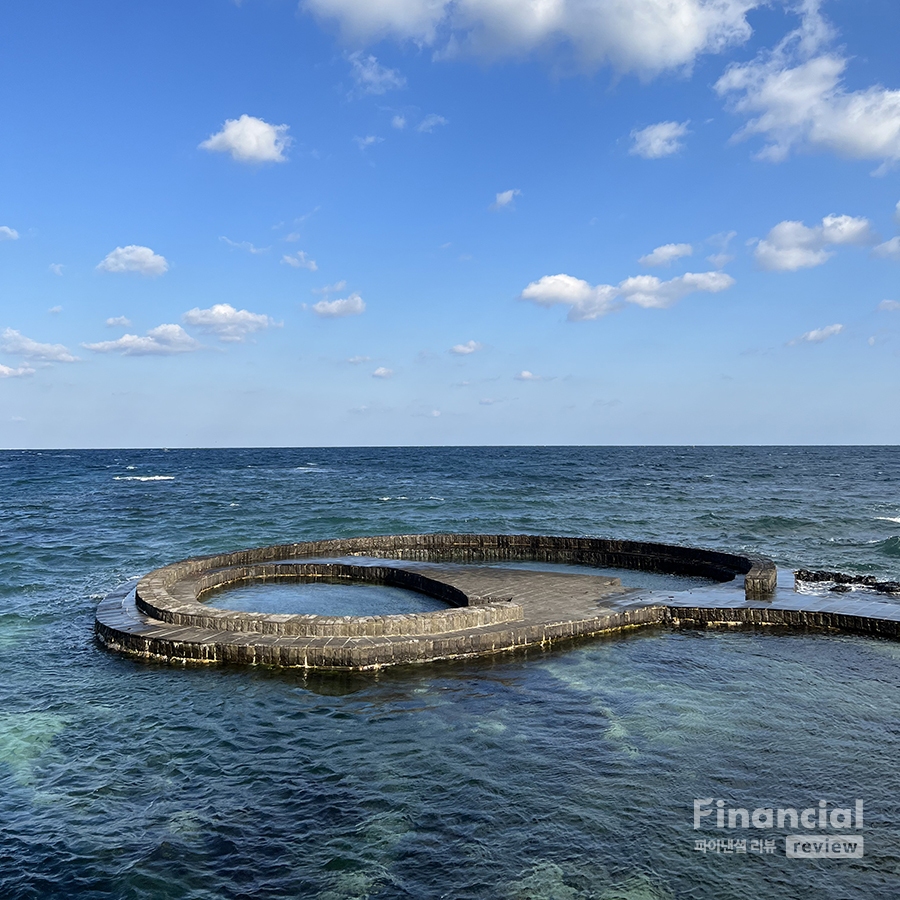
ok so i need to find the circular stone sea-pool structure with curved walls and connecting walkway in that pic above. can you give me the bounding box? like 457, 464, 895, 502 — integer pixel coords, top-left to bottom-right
95, 534, 900, 669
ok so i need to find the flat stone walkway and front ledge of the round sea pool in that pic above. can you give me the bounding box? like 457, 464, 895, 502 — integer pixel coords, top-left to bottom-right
96, 560, 900, 669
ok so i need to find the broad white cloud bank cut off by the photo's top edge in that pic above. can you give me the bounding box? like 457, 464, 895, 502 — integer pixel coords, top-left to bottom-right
304, 0, 761, 76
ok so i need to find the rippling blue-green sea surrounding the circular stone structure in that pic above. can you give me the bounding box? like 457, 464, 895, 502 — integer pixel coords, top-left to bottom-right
0, 447, 900, 900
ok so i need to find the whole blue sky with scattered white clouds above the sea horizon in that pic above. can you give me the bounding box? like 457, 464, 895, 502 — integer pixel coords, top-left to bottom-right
0, 0, 900, 448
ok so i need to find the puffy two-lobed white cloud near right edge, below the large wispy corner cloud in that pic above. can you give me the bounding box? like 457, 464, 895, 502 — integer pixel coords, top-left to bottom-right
754, 216, 876, 272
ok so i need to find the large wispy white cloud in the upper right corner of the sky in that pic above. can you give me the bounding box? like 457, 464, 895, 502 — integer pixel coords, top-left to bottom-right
715, 0, 900, 171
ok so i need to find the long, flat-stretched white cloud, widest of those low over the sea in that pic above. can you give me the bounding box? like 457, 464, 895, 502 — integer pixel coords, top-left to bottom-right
521, 272, 734, 322
